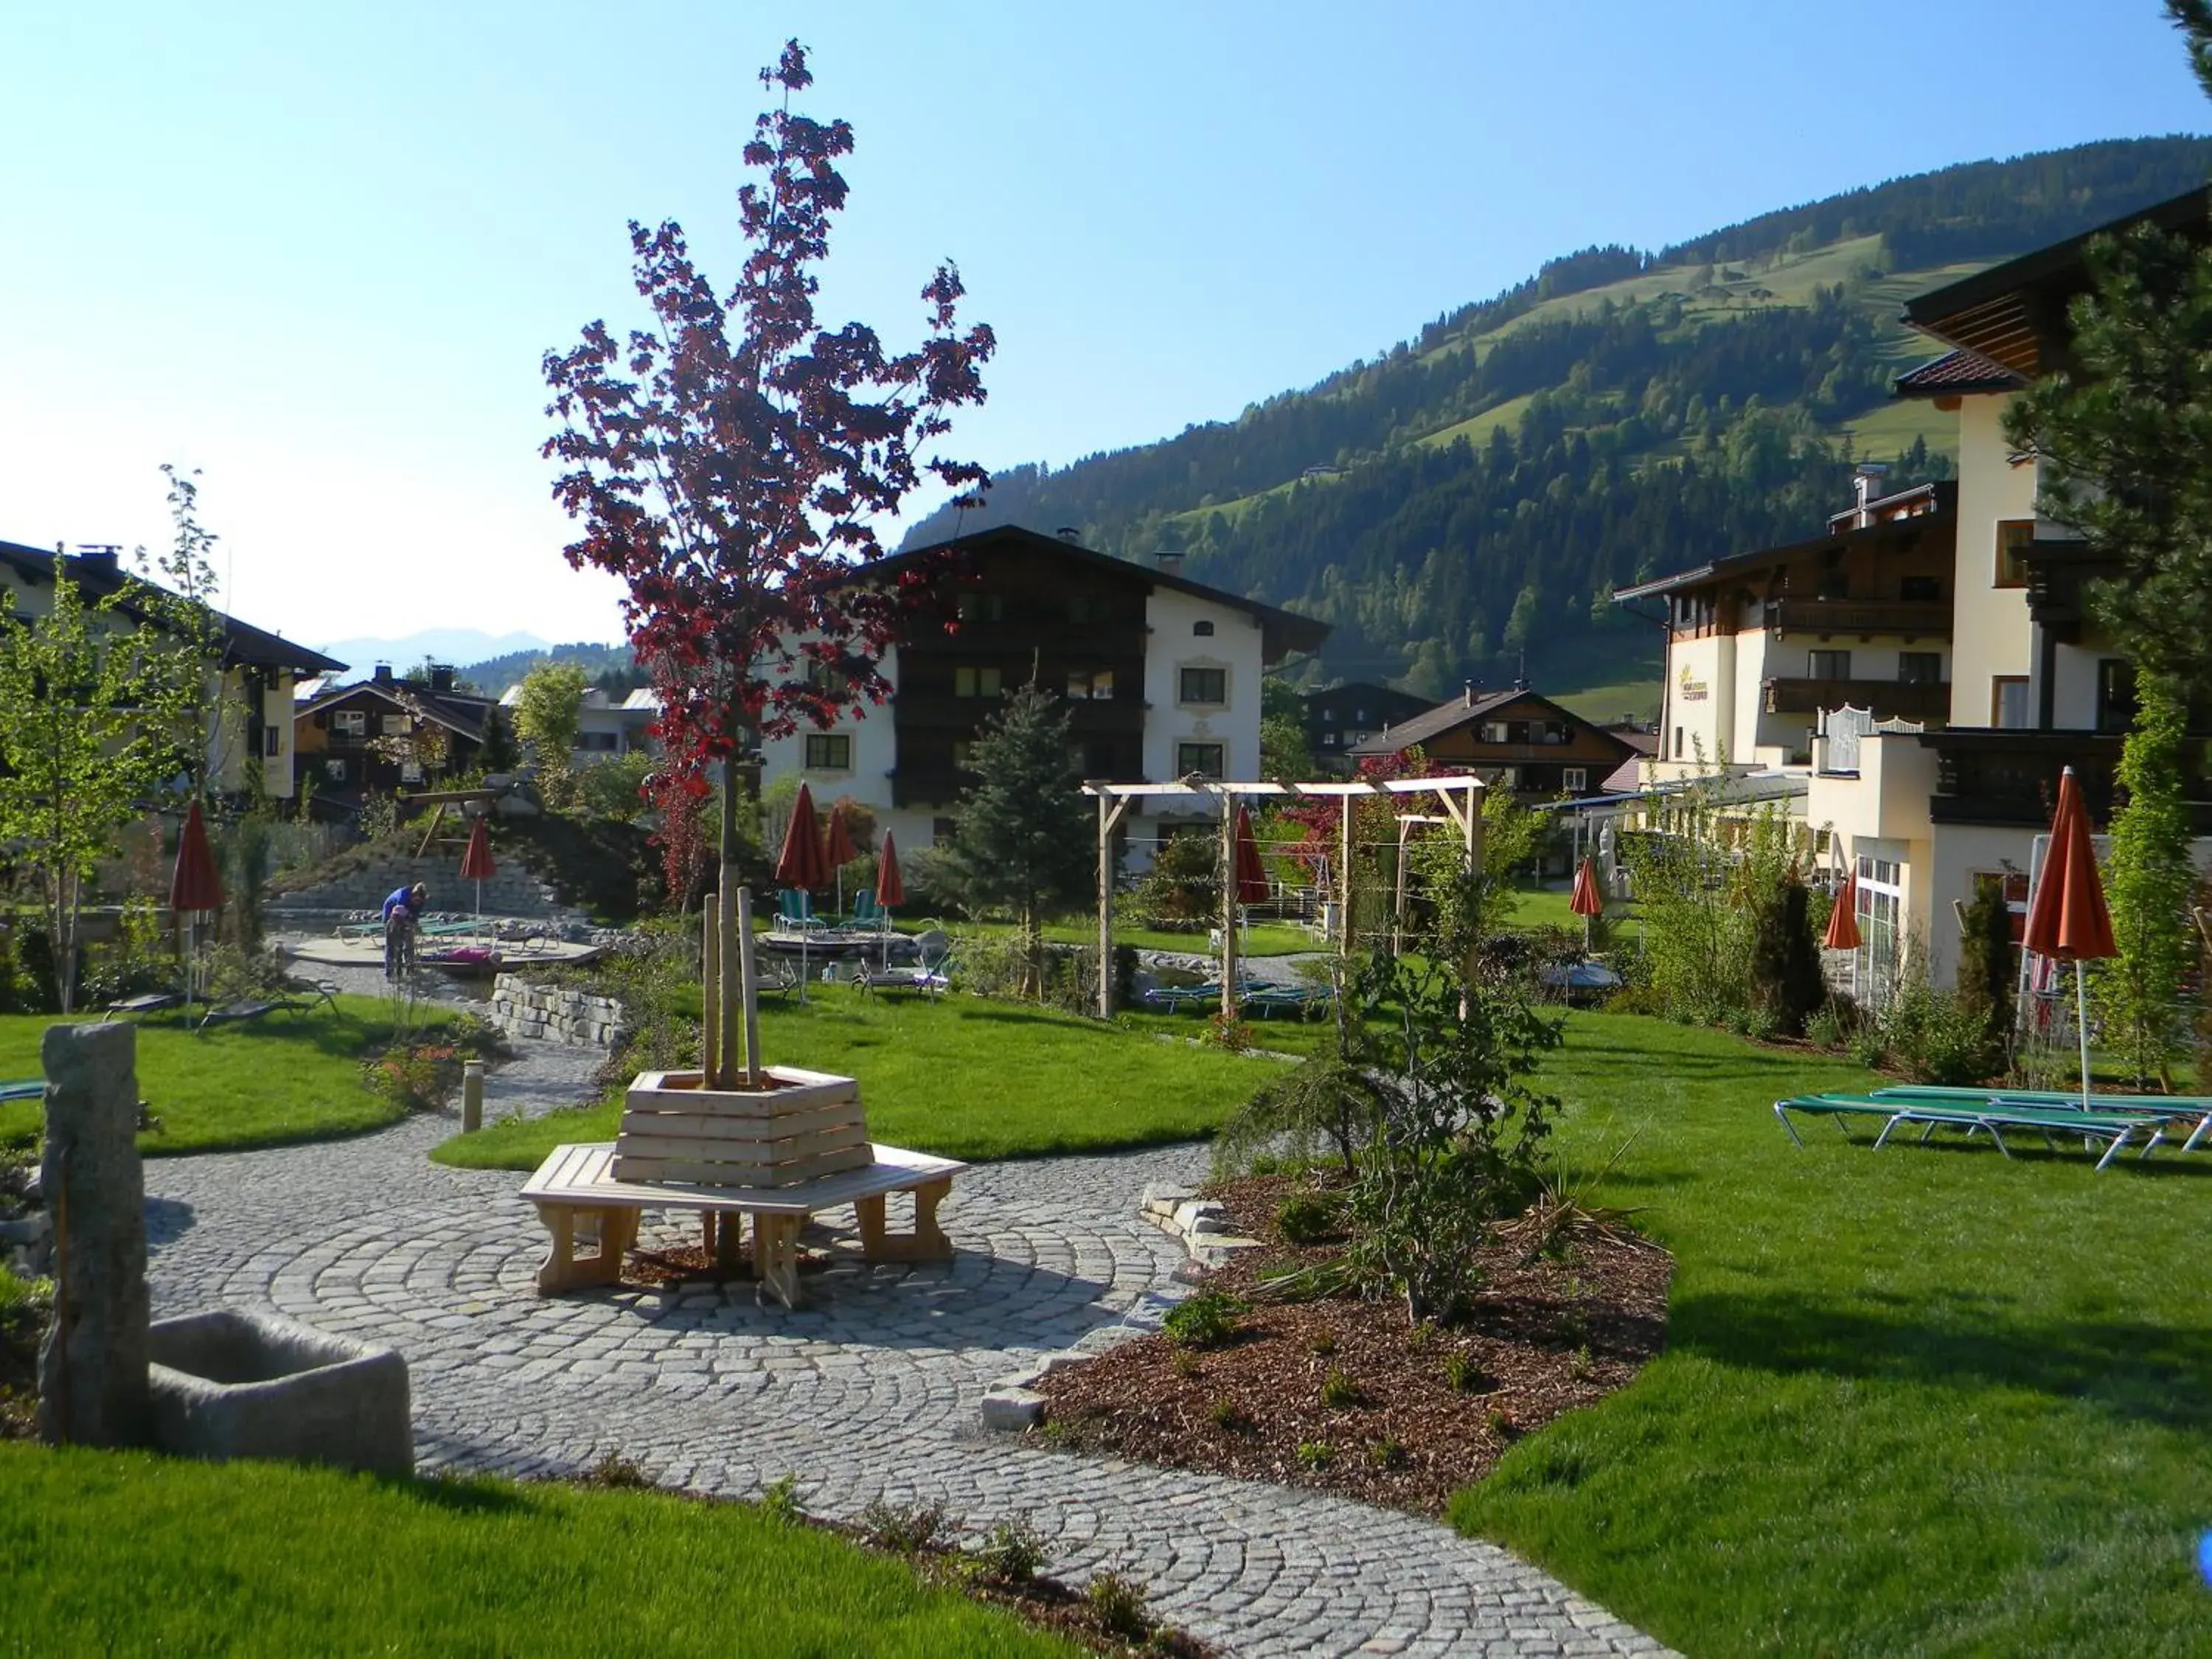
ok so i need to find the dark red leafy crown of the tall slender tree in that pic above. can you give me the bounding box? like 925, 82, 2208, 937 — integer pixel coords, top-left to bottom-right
544, 40, 993, 898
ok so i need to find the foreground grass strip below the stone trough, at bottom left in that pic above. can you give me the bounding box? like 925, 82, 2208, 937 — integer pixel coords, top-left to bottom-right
0, 1444, 1075, 1659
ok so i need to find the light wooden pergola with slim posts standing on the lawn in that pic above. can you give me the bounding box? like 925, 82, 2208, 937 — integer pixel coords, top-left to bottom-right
1084, 774, 1484, 1020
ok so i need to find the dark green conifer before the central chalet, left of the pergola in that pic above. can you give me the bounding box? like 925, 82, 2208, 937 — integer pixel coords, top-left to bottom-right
940, 681, 1097, 989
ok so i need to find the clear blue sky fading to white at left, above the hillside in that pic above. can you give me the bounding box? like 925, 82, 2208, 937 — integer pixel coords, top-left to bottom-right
0, 0, 2212, 641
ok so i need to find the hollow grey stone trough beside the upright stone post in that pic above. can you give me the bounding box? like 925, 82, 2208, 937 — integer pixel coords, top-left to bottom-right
146, 1307, 414, 1475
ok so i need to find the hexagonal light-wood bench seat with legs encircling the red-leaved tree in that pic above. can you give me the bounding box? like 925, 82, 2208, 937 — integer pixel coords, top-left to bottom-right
522, 1141, 967, 1307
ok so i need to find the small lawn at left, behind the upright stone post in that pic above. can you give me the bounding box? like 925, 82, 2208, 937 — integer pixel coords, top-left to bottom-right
0, 998, 471, 1157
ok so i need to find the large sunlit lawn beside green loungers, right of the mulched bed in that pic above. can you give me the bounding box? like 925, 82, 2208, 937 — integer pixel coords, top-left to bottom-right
1451, 1015, 2212, 1659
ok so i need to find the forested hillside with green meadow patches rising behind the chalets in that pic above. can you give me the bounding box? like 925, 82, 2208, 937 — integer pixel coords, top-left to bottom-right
907, 137, 2212, 695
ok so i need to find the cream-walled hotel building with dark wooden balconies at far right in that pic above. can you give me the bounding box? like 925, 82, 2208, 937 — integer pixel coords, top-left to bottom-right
1621, 190, 2212, 987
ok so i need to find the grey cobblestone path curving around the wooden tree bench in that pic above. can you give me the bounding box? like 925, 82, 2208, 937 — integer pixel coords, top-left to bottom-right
146, 1042, 1661, 1659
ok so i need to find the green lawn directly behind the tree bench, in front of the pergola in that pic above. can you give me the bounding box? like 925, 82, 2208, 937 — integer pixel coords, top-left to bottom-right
431, 984, 1276, 1170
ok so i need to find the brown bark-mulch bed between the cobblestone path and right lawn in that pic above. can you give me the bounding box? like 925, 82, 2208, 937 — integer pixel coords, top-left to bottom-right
1037, 1175, 1674, 1515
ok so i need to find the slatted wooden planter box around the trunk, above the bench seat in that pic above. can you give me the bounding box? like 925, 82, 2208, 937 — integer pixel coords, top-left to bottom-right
613, 1066, 874, 1188
